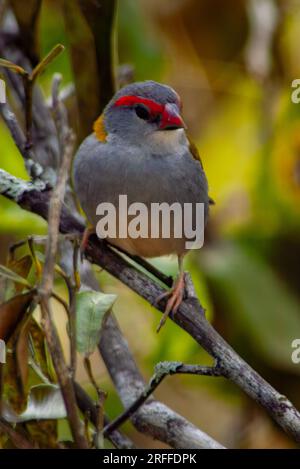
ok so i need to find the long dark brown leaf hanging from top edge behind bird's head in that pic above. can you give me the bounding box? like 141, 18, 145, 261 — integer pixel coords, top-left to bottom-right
64, 0, 116, 139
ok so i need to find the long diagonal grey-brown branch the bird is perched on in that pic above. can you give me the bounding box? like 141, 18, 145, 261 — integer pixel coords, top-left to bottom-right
0, 171, 300, 441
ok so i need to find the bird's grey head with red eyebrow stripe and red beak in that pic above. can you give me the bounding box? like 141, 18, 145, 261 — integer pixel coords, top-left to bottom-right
104, 80, 185, 143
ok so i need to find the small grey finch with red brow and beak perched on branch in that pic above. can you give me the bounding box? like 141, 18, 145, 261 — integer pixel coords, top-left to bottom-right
73, 80, 213, 331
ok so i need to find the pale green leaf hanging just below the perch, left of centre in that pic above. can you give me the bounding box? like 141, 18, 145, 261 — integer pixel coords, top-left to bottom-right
76, 291, 116, 355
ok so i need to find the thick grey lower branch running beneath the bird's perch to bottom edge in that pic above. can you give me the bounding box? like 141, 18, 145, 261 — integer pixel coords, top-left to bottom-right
99, 315, 223, 449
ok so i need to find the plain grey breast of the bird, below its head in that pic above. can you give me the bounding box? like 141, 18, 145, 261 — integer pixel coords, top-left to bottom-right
74, 135, 209, 254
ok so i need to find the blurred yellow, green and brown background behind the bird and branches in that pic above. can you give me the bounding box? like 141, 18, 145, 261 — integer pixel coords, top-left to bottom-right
0, 0, 300, 448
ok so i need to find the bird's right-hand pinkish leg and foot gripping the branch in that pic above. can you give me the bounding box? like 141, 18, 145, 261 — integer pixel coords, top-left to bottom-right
156, 255, 185, 332
